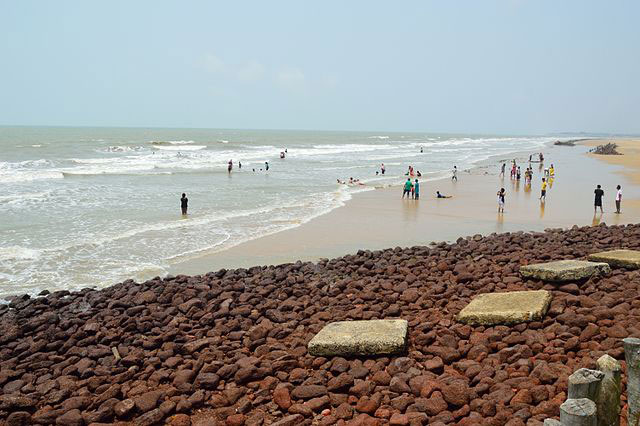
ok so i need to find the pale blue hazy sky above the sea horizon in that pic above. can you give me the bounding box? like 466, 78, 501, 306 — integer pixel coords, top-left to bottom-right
0, 0, 640, 134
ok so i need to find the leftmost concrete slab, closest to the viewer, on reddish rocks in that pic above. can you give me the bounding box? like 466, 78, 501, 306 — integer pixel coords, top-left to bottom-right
307, 319, 408, 356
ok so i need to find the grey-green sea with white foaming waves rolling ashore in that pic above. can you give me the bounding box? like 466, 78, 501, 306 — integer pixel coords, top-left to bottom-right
0, 127, 556, 299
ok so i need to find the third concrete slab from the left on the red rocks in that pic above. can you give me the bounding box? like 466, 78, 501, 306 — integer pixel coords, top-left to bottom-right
520, 260, 611, 282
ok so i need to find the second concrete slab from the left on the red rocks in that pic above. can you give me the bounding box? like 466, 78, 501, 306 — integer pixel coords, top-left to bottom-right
457, 290, 551, 325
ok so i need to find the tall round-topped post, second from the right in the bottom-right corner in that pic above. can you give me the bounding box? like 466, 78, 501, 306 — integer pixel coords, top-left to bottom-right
596, 355, 622, 426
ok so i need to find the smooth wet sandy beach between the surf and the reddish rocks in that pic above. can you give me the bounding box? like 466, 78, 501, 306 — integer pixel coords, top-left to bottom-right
170, 141, 640, 274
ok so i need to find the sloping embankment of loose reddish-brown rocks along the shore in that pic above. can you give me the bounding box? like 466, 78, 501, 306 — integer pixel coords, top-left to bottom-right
0, 225, 640, 426
